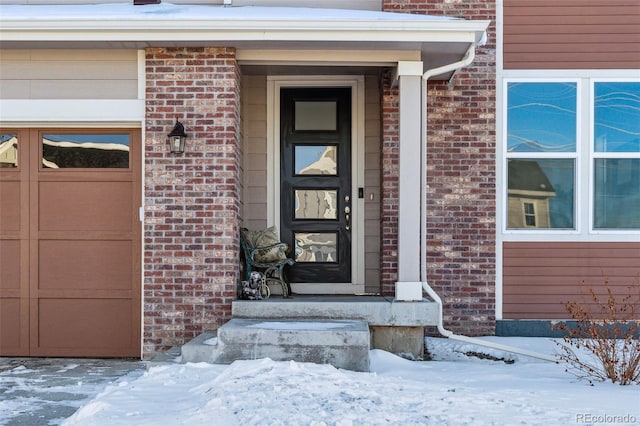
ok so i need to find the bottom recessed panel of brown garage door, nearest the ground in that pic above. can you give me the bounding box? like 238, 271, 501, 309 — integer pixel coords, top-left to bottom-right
32, 299, 140, 356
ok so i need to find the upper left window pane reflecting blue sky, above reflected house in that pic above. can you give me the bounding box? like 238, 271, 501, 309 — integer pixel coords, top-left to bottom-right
507, 82, 577, 152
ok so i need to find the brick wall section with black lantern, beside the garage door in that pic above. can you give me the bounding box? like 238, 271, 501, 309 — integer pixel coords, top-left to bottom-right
143, 48, 240, 357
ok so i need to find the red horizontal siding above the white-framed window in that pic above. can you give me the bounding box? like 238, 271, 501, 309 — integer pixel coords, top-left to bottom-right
503, 0, 640, 69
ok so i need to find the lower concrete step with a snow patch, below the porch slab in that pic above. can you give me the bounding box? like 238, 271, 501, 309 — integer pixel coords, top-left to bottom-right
182, 318, 370, 371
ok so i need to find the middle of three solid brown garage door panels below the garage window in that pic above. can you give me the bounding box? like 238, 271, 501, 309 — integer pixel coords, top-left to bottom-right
38, 240, 133, 291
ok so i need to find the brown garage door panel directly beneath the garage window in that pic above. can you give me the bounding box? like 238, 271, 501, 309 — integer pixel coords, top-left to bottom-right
38, 182, 133, 231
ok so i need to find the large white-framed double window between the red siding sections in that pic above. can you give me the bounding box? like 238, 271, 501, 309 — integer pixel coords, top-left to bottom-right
503, 78, 640, 233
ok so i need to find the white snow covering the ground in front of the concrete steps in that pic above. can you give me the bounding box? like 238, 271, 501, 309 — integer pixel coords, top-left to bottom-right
63, 337, 640, 426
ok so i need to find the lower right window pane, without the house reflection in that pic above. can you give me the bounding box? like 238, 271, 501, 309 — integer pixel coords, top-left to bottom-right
594, 158, 640, 229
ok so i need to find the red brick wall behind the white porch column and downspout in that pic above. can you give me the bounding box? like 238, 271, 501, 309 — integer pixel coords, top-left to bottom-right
382, 0, 496, 335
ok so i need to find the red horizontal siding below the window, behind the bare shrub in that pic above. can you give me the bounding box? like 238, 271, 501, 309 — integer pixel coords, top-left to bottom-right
502, 242, 640, 319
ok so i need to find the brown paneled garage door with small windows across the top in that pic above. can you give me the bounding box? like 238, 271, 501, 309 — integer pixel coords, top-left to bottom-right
0, 129, 141, 357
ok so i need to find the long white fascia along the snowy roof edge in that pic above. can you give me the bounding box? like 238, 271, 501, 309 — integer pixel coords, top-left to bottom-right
0, 18, 489, 43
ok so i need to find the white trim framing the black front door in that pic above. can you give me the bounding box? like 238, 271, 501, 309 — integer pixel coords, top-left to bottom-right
267, 76, 364, 294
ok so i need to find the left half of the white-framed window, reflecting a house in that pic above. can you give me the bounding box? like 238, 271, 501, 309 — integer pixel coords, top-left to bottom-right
505, 81, 579, 229
